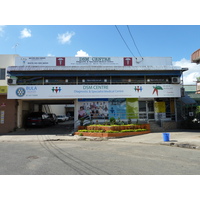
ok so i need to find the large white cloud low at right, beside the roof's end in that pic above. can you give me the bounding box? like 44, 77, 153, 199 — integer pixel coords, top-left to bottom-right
173, 58, 200, 85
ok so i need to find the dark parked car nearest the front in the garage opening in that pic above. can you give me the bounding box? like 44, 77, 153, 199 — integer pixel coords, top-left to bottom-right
26, 112, 51, 126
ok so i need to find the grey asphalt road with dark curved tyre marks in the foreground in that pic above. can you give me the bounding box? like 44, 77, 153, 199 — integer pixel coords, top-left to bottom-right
0, 138, 200, 175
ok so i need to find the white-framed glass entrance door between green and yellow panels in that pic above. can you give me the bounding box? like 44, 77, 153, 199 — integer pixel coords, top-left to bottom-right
139, 101, 155, 121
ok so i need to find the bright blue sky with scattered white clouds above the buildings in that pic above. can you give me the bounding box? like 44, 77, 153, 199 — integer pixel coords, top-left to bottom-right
0, 25, 200, 84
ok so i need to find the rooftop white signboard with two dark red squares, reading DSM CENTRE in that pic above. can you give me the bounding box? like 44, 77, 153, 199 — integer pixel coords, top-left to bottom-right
15, 57, 174, 67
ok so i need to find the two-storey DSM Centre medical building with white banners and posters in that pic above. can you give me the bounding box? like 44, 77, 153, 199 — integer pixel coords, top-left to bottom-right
8, 57, 187, 131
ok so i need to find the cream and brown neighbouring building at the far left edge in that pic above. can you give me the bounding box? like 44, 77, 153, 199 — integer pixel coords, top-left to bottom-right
0, 54, 18, 134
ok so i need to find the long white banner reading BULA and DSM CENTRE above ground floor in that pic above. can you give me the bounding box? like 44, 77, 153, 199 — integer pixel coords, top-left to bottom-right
8, 84, 181, 99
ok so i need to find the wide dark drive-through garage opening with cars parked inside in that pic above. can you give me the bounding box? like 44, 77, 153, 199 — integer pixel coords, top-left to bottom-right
18, 99, 74, 134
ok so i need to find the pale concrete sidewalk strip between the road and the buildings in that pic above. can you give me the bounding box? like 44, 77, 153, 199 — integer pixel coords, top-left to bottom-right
0, 130, 200, 149
